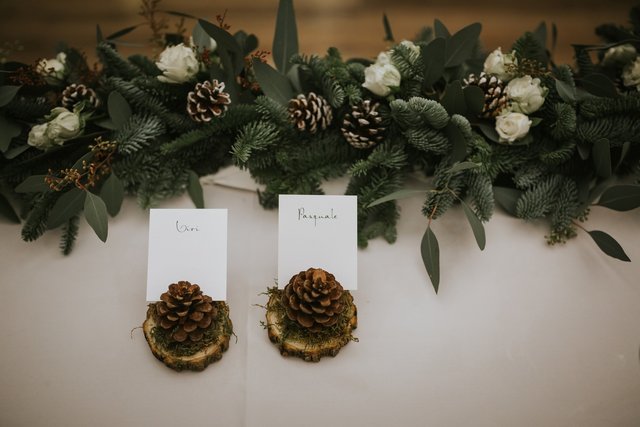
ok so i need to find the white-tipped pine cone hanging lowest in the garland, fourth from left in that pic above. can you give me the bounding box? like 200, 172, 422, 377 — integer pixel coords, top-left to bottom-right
342, 99, 385, 148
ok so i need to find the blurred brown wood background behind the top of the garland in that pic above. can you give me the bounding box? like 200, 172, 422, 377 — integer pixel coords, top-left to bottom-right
0, 0, 634, 63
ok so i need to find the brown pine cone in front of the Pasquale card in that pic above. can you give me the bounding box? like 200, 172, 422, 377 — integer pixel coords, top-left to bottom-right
280, 268, 344, 331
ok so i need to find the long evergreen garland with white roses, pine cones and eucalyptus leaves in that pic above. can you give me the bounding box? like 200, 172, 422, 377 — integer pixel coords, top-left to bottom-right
0, 0, 640, 292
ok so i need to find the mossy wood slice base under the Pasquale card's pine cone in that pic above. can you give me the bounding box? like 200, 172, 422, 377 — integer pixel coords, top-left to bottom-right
266, 289, 358, 362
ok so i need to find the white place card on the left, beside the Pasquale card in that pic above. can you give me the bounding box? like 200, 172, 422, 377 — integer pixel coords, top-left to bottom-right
147, 209, 227, 302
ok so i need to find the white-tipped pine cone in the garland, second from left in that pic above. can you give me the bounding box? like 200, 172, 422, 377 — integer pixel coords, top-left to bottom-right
187, 80, 231, 123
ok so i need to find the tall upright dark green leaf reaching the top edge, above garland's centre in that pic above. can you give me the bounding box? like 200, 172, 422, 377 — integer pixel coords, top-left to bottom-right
272, 0, 298, 74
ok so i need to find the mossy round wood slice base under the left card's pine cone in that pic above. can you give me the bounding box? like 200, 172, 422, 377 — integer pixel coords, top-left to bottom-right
142, 301, 233, 371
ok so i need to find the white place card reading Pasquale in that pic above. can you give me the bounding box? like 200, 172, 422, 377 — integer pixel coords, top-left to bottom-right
278, 195, 358, 290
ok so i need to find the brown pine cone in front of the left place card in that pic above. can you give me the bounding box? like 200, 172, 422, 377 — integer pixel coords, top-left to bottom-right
156, 281, 218, 342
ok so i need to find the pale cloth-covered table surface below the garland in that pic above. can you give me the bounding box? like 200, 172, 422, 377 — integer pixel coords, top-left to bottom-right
0, 169, 640, 427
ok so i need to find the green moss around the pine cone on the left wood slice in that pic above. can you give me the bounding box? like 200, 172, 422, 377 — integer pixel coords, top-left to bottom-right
151, 301, 233, 356
